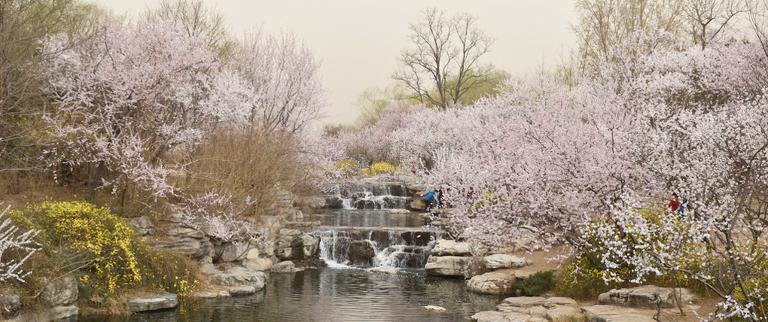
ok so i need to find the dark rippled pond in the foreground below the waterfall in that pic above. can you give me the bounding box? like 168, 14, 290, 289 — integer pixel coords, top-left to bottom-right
102, 267, 501, 321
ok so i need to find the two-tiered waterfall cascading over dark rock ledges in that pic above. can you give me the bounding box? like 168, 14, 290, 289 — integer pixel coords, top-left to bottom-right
313, 182, 439, 268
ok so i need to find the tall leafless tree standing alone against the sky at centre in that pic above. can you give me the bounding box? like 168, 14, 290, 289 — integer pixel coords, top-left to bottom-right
393, 8, 493, 110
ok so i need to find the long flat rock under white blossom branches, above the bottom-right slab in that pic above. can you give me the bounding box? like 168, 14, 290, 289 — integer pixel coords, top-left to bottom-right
597, 285, 696, 309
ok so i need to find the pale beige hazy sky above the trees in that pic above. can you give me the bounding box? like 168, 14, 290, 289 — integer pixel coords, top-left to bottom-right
94, 0, 575, 123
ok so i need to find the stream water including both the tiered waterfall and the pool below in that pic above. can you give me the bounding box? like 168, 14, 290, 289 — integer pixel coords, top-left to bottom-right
88, 184, 501, 321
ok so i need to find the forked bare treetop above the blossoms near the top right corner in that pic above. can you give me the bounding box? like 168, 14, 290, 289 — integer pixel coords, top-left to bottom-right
685, 0, 746, 49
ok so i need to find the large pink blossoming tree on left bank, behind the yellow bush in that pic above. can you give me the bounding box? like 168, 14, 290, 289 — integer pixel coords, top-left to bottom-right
41, 20, 251, 197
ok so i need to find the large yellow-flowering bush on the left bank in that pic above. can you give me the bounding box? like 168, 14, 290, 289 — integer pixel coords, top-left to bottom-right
11, 202, 141, 295
